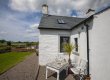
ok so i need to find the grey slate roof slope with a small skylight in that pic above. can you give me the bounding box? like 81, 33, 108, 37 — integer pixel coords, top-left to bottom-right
38, 14, 86, 30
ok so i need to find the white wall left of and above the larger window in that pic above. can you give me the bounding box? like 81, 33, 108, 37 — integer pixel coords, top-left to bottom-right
39, 29, 70, 65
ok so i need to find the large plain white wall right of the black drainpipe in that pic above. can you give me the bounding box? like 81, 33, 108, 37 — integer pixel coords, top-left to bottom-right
89, 9, 110, 80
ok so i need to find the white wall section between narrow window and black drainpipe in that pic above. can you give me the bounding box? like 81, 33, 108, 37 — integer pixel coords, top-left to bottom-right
71, 24, 87, 60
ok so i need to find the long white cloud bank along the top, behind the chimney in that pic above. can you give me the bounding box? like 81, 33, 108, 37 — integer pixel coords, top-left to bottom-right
9, 0, 110, 17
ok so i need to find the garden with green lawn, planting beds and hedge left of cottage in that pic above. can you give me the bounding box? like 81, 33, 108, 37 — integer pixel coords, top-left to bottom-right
0, 40, 38, 74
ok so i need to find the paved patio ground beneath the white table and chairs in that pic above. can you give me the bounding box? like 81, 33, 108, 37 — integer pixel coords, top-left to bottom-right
37, 66, 75, 80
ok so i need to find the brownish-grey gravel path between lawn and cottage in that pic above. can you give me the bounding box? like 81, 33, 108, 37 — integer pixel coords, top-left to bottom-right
0, 54, 38, 80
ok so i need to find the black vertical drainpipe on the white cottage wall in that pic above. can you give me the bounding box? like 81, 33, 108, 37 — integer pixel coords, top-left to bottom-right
84, 23, 90, 77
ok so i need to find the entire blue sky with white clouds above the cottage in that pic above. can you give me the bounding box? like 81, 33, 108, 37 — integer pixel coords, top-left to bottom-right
0, 0, 110, 41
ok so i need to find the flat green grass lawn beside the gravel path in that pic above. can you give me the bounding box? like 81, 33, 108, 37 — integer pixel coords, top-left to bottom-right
0, 52, 32, 74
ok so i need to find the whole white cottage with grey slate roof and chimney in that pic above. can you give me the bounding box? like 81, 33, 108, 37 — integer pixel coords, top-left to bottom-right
38, 5, 110, 80
